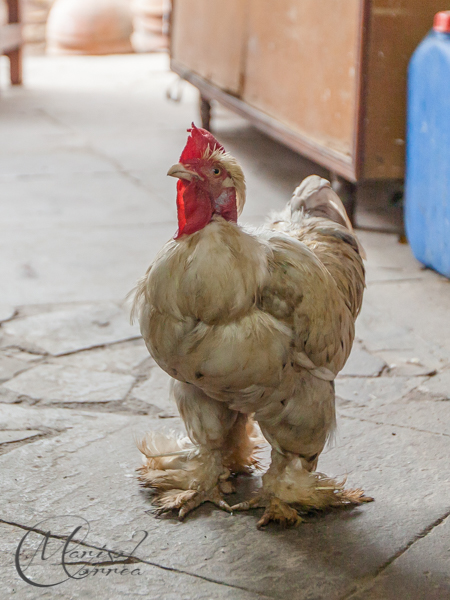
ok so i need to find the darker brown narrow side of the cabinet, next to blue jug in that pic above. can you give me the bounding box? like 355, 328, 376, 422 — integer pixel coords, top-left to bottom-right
362, 0, 445, 179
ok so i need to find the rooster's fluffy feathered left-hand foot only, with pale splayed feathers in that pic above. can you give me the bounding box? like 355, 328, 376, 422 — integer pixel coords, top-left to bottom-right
138, 433, 234, 520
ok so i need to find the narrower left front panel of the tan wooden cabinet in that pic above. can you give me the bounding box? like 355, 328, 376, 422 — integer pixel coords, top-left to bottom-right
171, 0, 247, 95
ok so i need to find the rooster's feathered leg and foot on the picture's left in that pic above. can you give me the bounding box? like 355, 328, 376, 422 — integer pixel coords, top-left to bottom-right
139, 381, 253, 519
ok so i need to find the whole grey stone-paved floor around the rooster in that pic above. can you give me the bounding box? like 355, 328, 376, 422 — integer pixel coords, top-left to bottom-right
0, 55, 450, 600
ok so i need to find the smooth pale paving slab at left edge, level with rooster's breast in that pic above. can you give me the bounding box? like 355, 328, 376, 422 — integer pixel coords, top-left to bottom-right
0, 221, 177, 305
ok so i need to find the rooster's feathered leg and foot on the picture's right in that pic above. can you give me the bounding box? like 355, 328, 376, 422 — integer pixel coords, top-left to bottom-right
232, 380, 372, 528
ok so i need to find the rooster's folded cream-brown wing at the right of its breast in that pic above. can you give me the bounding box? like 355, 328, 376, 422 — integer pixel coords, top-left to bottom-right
260, 232, 354, 380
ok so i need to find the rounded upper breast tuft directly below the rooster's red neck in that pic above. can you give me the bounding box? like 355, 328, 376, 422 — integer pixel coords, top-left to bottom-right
145, 218, 268, 325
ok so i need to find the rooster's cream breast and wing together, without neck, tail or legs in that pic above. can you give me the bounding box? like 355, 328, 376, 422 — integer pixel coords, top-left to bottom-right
135, 219, 362, 402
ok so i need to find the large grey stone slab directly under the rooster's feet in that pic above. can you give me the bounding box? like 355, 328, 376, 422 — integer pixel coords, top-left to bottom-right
0, 407, 450, 600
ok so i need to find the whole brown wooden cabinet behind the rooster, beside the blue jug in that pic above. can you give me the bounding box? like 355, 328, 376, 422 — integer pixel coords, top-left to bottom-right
171, 0, 442, 188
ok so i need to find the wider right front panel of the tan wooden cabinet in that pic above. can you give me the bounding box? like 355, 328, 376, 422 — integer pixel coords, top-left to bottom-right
244, 0, 360, 156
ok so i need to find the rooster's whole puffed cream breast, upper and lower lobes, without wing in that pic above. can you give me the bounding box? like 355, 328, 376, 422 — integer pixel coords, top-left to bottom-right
135, 219, 284, 390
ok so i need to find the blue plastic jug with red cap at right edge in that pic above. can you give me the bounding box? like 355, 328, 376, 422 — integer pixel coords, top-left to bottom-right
405, 11, 450, 277
